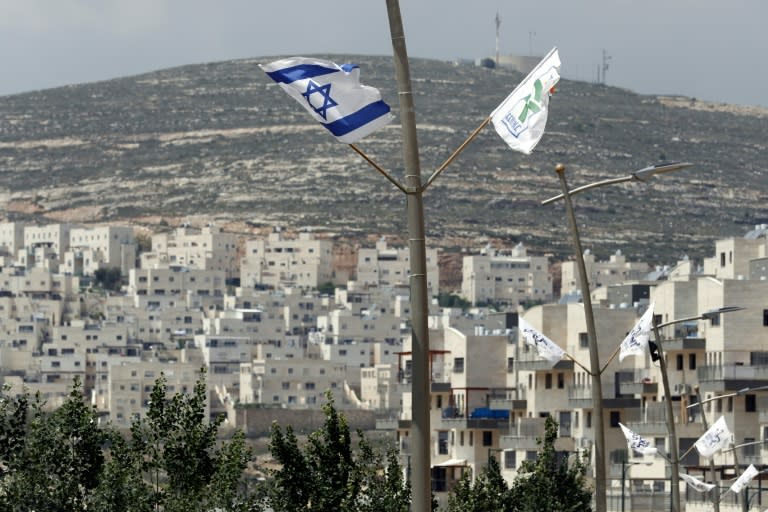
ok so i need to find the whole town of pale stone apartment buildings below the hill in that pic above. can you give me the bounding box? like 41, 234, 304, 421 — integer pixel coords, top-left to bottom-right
0, 218, 768, 510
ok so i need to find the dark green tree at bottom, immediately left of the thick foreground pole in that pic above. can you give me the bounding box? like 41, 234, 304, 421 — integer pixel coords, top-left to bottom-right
268, 393, 411, 512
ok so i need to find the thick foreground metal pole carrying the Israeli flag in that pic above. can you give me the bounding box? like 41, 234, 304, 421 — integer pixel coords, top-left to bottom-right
387, 0, 428, 512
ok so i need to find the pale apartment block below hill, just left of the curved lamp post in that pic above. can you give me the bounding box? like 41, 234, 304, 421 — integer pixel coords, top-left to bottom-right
461, 243, 552, 306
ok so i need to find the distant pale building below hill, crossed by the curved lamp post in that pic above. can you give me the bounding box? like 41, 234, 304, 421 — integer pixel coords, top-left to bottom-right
560, 249, 650, 295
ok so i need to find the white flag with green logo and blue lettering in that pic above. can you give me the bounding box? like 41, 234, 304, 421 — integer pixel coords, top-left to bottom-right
491, 48, 560, 155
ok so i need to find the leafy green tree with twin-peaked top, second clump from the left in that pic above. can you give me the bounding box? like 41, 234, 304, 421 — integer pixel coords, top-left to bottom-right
91, 370, 251, 512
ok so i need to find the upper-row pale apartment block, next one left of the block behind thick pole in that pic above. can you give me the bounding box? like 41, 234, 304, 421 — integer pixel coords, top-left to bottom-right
240, 231, 334, 290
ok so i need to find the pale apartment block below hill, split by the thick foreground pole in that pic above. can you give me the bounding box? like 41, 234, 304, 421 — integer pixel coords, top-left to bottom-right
357, 239, 440, 295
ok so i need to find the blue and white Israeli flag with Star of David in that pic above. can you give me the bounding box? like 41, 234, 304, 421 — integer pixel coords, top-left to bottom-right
260, 57, 393, 144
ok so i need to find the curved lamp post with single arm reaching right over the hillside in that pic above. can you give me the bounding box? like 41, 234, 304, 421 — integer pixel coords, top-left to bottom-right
542, 163, 693, 512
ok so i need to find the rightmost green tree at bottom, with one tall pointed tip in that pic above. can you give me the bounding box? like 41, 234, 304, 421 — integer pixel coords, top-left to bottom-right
507, 416, 592, 512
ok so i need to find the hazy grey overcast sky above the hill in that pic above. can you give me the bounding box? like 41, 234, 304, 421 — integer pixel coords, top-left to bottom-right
0, 0, 768, 107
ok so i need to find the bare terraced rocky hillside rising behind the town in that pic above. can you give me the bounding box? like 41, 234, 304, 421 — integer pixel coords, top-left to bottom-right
0, 55, 768, 264
